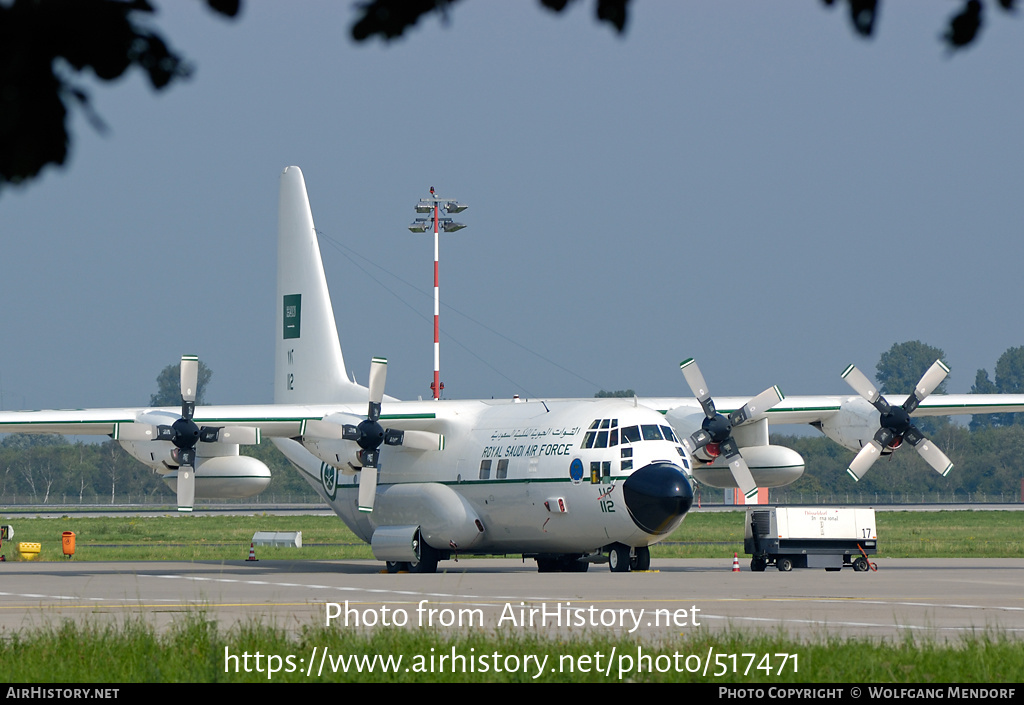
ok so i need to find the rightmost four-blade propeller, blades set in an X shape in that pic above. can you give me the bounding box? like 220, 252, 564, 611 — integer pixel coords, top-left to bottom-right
843, 360, 953, 481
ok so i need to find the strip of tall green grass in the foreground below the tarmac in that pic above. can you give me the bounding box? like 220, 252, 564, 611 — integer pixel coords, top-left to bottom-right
0, 613, 1024, 686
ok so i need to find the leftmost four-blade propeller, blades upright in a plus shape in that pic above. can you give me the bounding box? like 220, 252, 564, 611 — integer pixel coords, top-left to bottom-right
114, 355, 260, 511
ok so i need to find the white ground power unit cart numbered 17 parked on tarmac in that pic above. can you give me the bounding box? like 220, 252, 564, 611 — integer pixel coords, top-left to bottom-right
743, 506, 878, 572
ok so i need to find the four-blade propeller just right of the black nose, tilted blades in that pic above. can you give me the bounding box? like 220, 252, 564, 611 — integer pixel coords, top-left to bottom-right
679, 358, 783, 499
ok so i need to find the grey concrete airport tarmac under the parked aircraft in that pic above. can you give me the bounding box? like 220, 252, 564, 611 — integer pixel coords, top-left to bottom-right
0, 557, 1024, 640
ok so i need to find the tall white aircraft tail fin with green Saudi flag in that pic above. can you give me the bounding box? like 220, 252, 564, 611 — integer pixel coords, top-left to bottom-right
273, 166, 367, 404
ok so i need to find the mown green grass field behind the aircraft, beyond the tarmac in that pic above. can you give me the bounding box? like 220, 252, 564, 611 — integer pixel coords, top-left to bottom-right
0, 511, 1024, 561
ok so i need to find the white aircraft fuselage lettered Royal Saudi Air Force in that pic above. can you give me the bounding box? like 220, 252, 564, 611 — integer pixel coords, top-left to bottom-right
279, 400, 691, 553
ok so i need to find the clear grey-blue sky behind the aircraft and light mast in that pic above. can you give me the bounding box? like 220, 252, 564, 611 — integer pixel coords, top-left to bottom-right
0, 0, 1024, 410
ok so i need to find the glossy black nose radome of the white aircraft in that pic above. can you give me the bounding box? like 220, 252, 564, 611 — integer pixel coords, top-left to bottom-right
623, 462, 693, 535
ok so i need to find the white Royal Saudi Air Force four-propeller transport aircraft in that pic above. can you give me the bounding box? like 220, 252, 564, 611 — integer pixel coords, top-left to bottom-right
0, 167, 1024, 573
